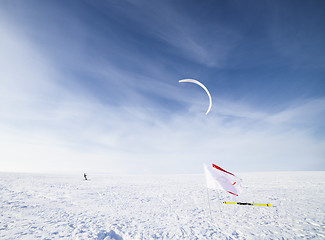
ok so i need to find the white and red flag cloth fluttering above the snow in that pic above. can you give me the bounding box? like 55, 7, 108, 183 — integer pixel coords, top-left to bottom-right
204, 164, 241, 196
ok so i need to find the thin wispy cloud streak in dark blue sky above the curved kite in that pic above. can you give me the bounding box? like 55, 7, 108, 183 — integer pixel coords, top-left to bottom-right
86, 1, 241, 67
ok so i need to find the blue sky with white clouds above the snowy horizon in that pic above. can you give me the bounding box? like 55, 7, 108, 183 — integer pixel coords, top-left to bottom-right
0, 0, 325, 174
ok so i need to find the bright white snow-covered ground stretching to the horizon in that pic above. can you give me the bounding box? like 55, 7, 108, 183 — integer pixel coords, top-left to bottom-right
0, 172, 325, 240
